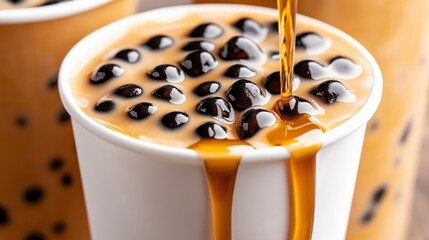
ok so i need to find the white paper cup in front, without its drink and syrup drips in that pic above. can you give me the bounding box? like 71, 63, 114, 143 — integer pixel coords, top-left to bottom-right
60, 5, 382, 240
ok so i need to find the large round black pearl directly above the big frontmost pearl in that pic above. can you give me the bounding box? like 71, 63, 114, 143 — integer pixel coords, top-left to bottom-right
226, 79, 265, 111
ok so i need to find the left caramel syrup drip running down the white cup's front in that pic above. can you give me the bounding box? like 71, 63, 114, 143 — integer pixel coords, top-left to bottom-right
190, 140, 254, 240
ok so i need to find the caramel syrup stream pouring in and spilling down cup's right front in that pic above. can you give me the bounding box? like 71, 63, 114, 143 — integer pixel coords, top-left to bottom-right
278, 0, 323, 240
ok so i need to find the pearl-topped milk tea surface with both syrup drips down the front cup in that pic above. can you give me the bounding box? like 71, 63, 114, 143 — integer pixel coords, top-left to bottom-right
71, 7, 374, 240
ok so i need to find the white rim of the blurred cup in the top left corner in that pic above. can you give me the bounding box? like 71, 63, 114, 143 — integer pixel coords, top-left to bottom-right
0, 0, 112, 24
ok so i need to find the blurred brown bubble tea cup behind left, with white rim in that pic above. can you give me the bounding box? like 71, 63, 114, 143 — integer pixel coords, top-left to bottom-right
0, 0, 135, 240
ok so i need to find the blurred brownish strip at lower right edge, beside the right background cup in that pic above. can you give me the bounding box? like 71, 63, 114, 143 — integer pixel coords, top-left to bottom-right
409, 109, 429, 240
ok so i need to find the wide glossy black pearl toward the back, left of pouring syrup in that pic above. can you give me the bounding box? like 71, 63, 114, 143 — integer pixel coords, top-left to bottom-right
220, 37, 264, 62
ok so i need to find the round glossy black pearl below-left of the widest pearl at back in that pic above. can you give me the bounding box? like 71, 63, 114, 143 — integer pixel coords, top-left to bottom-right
180, 51, 218, 77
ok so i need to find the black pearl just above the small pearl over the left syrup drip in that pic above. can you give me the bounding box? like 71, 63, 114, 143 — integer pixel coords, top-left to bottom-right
196, 97, 235, 122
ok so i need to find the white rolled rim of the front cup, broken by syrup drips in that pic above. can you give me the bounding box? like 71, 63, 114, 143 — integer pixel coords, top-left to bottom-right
59, 4, 383, 159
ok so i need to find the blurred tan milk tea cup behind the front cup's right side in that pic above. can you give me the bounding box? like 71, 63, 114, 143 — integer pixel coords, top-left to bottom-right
189, 0, 429, 240
